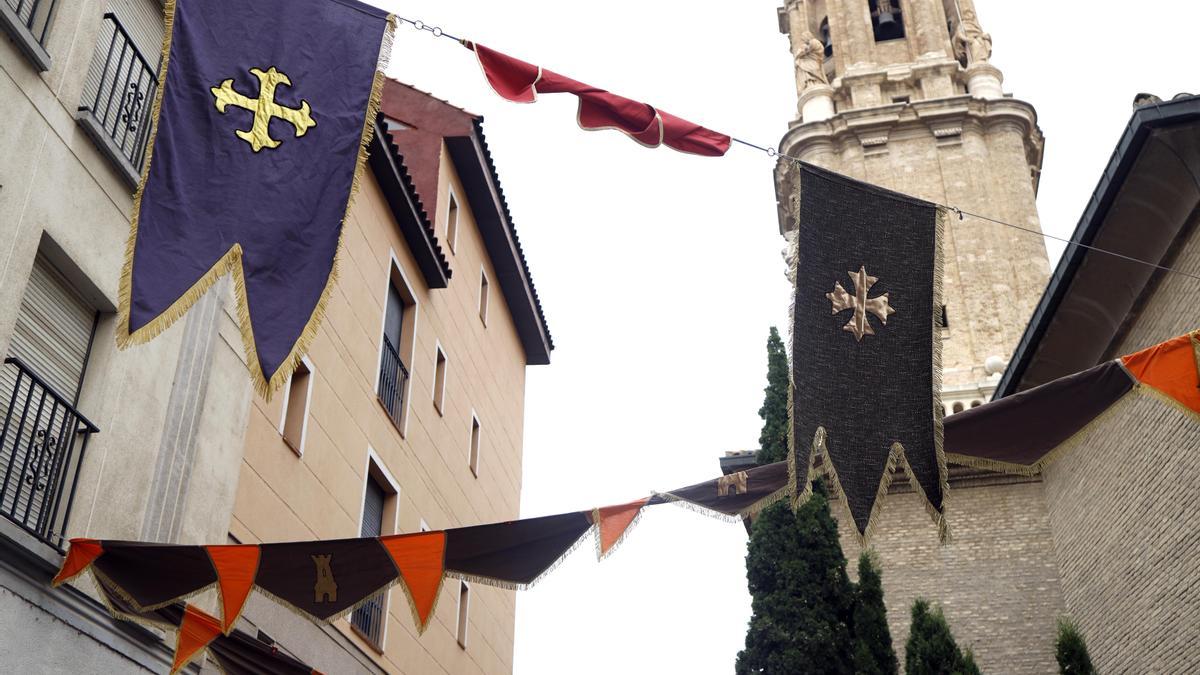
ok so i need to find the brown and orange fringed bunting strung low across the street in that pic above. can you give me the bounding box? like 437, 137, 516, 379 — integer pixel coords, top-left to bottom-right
53, 331, 1200, 653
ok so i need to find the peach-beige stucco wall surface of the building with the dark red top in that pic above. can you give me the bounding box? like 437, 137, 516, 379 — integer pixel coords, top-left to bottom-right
230, 142, 524, 675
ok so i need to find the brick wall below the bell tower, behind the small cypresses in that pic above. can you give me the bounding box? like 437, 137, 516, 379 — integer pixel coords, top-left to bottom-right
833, 477, 1064, 674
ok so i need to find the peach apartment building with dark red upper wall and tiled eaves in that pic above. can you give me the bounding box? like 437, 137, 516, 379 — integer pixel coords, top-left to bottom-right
229, 80, 551, 675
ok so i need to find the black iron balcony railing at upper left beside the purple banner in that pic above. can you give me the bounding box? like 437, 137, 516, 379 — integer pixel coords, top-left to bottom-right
79, 12, 158, 178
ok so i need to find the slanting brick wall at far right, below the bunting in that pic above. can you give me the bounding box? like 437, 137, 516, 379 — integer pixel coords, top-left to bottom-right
1045, 381, 1200, 673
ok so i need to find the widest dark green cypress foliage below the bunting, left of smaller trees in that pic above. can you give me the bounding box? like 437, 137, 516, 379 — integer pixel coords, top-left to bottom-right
736, 483, 854, 675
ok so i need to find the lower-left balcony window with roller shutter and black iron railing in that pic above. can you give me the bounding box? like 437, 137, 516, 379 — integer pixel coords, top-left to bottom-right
0, 256, 98, 550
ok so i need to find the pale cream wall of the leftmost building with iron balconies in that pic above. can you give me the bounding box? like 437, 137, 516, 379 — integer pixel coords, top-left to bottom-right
0, 0, 250, 543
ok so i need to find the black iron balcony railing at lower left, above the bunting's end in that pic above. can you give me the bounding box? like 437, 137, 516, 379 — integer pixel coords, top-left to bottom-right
0, 357, 100, 551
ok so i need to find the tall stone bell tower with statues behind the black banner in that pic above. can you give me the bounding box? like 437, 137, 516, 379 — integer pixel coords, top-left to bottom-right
775, 0, 1049, 403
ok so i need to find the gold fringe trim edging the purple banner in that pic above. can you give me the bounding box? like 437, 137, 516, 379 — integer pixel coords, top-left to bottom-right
116, 6, 396, 401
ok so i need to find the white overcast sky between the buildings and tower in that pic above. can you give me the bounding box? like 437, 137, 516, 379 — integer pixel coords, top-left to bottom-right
386, 0, 1200, 675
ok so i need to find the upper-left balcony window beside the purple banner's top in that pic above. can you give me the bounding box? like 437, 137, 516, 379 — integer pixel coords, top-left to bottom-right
77, 10, 162, 185
